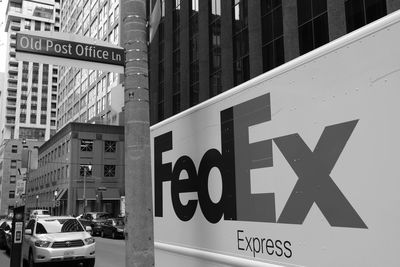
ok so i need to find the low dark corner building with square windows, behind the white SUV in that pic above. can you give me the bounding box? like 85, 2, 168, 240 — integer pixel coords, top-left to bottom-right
25, 122, 125, 216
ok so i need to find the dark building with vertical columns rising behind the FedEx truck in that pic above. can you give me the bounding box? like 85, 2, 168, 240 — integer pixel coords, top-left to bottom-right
149, 0, 400, 124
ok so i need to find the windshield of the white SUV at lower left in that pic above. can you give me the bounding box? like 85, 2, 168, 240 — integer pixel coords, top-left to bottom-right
36, 219, 84, 234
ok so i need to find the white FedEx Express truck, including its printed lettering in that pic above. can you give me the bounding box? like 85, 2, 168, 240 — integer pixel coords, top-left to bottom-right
151, 9, 400, 267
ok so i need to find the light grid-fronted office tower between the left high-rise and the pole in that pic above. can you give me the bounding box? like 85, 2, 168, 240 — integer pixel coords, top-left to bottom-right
57, 0, 124, 129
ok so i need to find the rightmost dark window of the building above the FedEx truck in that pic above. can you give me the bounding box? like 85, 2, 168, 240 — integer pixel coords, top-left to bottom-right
345, 0, 387, 32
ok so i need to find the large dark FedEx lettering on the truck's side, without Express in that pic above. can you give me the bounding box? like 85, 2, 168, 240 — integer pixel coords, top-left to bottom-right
154, 94, 367, 228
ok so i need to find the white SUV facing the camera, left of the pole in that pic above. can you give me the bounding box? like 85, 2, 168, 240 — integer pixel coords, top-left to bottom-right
22, 216, 96, 267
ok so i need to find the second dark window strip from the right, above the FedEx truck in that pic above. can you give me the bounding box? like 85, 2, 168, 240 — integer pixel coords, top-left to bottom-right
297, 0, 329, 55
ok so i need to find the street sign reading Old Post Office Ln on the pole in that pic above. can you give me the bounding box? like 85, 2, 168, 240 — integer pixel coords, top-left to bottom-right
15, 31, 125, 73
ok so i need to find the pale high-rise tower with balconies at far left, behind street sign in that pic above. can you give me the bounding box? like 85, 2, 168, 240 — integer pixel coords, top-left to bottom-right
0, 0, 60, 140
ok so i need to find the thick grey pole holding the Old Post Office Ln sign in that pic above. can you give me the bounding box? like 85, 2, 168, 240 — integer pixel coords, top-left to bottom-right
120, 0, 154, 267
